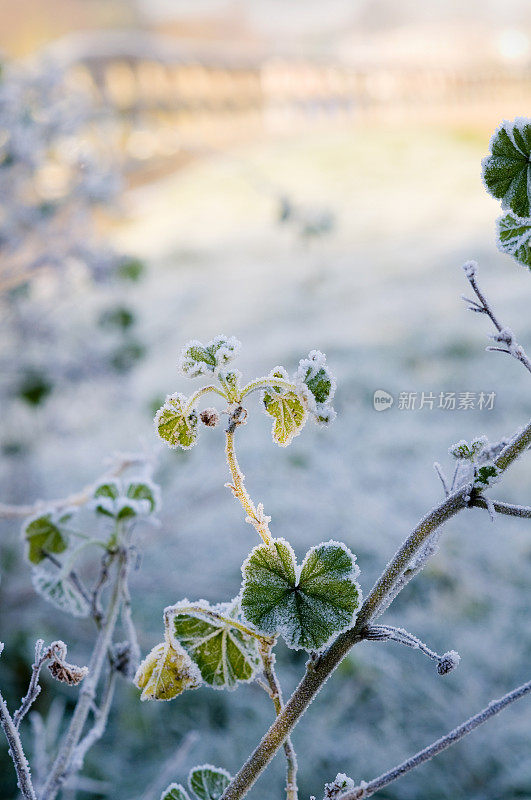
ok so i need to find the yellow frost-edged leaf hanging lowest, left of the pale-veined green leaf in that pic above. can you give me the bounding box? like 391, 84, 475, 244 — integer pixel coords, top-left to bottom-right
134, 639, 201, 700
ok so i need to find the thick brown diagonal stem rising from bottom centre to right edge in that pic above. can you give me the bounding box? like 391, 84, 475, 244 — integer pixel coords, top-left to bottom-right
222, 421, 531, 800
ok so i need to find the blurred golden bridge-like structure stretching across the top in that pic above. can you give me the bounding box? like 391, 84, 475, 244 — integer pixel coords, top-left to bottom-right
43, 32, 531, 180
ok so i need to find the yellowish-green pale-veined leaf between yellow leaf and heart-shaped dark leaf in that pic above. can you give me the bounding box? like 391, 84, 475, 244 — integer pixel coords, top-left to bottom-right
164, 600, 260, 689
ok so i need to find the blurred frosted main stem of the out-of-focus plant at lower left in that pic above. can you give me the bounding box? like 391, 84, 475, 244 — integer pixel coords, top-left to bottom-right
39, 549, 127, 800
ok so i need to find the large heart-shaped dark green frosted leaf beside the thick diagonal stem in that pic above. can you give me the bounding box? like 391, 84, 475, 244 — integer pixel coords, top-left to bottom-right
241, 539, 361, 651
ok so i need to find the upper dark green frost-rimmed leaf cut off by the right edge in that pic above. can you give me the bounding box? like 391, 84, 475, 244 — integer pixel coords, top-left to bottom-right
481, 117, 531, 217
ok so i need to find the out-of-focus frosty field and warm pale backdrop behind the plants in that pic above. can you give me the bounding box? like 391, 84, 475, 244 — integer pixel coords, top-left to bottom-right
0, 0, 531, 800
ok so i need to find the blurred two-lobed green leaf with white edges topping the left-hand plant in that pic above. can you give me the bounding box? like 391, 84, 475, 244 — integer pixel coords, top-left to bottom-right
93, 479, 160, 519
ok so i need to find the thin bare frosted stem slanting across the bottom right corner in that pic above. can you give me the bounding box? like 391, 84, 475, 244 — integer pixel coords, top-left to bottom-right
341, 681, 531, 800
